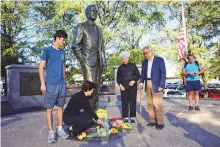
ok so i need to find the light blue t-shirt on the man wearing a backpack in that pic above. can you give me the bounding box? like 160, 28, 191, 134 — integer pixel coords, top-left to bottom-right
182, 62, 201, 81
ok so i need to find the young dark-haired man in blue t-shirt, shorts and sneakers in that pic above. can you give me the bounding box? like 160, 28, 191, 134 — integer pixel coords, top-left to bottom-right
39, 30, 69, 143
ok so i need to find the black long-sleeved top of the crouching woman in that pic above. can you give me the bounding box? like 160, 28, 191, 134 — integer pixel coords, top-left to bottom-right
64, 91, 98, 120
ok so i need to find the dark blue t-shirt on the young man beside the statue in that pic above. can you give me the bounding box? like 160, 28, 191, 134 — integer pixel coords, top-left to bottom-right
41, 46, 65, 84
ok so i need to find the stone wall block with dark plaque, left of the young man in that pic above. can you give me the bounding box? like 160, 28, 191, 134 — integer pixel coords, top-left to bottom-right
6, 65, 44, 110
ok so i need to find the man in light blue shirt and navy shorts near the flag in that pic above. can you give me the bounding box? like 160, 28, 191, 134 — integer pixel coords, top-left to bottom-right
182, 54, 204, 111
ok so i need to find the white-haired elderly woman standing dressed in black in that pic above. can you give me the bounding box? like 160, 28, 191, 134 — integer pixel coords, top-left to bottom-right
117, 51, 140, 123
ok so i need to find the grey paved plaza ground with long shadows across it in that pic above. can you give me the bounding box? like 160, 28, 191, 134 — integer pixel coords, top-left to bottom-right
1, 99, 220, 147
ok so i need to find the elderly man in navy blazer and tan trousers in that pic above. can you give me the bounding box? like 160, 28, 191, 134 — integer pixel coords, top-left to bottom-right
139, 46, 166, 130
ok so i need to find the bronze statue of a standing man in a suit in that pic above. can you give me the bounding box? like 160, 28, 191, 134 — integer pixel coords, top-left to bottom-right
72, 5, 107, 88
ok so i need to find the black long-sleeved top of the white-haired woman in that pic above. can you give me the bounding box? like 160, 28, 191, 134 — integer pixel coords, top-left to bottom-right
117, 62, 140, 90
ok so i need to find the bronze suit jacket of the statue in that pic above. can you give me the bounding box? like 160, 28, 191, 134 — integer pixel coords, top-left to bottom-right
72, 21, 106, 67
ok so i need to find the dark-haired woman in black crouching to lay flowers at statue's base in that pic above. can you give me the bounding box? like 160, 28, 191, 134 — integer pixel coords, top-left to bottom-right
63, 81, 104, 139
